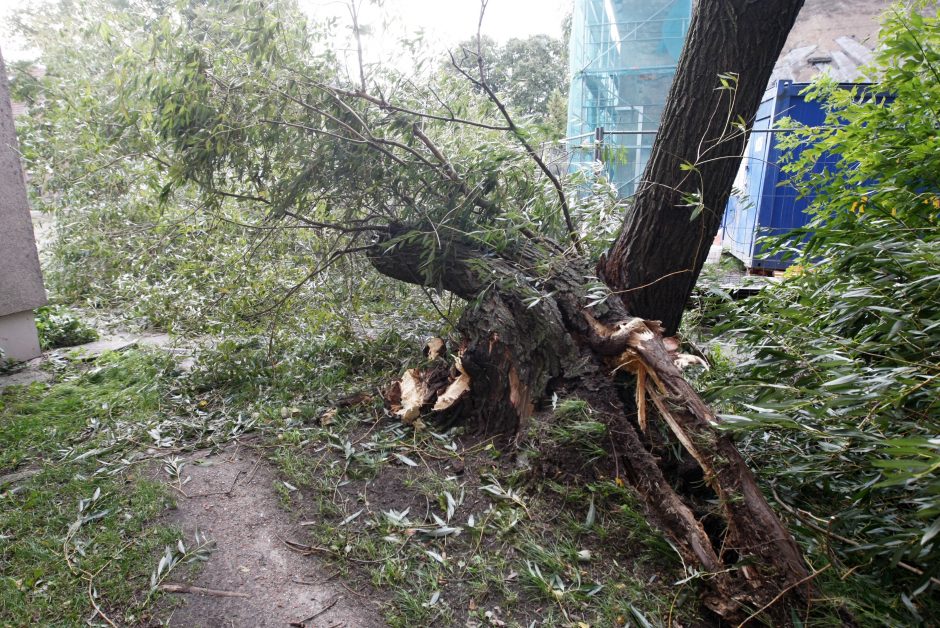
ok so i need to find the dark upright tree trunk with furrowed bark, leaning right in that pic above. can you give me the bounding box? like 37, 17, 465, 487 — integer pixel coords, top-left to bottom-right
597, 0, 803, 335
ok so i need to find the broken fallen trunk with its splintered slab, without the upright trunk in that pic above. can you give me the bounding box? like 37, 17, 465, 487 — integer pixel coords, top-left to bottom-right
371, 228, 807, 619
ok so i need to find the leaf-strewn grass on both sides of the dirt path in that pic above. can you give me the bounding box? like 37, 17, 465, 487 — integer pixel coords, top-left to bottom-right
0, 335, 697, 626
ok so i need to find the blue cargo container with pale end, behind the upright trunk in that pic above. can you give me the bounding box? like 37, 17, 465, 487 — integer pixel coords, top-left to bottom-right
722, 81, 893, 271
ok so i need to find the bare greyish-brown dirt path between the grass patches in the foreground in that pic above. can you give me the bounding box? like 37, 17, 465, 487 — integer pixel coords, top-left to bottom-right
166, 444, 386, 628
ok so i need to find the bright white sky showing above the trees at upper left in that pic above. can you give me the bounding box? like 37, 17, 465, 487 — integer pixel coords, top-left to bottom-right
0, 0, 573, 64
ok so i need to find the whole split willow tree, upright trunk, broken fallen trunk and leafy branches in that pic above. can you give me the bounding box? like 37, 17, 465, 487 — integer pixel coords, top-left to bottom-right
126, 0, 811, 621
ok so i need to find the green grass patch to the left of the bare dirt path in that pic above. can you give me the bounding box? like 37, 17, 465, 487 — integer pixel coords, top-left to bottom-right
0, 352, 179, 626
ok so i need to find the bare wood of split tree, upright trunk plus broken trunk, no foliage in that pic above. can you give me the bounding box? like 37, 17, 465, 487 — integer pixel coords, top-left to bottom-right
370, 0, 811, 622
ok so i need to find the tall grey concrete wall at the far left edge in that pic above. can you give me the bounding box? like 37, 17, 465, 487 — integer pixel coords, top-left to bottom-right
0, 46, 46, 361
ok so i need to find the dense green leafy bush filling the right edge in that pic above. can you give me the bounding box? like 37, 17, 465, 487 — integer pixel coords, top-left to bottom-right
709, 6, 940, 621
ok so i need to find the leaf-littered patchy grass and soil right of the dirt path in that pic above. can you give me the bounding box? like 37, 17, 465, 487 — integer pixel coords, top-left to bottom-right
262, 348, 697, 626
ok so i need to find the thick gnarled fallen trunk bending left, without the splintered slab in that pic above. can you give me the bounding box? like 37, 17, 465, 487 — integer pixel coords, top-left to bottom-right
370, 226, 583, 436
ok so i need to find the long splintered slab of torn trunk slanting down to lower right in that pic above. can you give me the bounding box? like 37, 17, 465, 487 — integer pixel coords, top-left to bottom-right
589, 318, 808, 617
